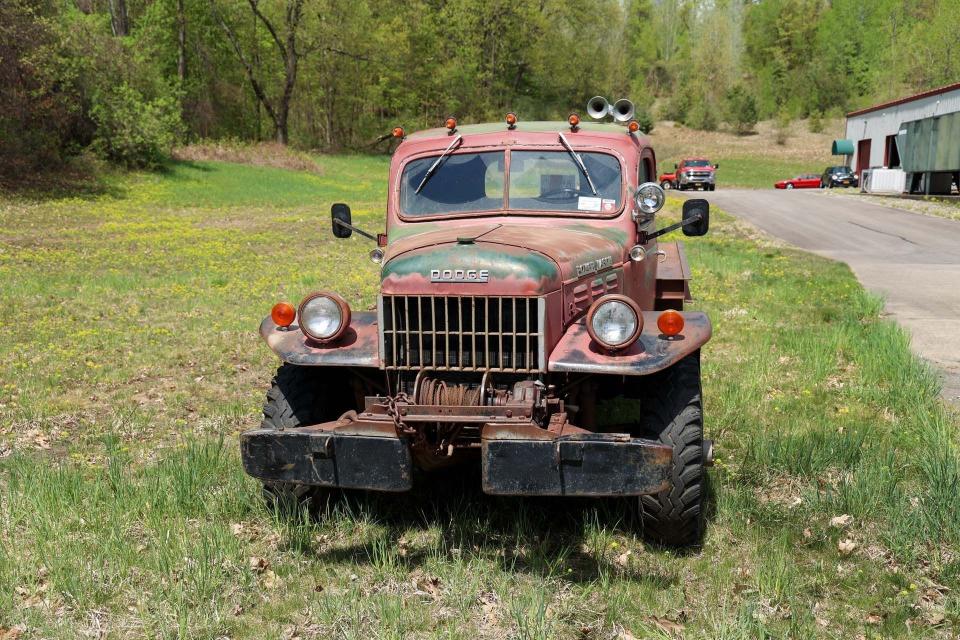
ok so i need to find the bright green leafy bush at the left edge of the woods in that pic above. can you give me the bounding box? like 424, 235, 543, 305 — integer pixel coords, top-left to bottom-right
90, 83, 181, 168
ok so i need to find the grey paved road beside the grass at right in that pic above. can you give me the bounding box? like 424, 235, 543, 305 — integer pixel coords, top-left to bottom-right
684, 189, 960, 400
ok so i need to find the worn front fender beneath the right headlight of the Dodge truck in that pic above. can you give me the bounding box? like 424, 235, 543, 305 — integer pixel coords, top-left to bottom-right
547, 311, 713, 376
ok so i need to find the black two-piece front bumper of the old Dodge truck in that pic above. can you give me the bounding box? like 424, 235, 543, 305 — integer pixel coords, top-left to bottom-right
240, 418, 672, 497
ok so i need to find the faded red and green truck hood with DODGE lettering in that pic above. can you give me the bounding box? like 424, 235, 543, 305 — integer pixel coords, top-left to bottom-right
381, 221, 627, 296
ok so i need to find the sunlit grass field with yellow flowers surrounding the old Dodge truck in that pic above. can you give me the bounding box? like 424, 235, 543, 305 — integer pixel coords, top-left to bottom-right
0, 157, 960, 639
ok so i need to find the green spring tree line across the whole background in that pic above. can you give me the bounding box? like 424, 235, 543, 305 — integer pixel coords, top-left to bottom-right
0, 0, 960, 174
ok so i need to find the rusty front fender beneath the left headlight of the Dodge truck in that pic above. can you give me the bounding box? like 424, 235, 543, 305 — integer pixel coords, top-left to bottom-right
260, 311, 380, 368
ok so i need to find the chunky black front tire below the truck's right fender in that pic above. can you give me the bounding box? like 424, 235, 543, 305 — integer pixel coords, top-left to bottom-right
640, 351, 704, 546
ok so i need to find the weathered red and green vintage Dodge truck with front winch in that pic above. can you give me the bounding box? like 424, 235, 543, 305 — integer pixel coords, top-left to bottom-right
241, 101, 712, 545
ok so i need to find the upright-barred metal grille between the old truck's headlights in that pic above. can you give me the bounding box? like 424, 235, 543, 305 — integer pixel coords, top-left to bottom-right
377, 296, 546, 371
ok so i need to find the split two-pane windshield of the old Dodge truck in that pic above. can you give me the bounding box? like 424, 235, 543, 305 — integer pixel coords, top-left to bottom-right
400, 150, 621, 216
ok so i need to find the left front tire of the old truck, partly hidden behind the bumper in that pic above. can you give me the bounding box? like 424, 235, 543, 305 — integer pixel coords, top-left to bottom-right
260, 364, 345, 511
